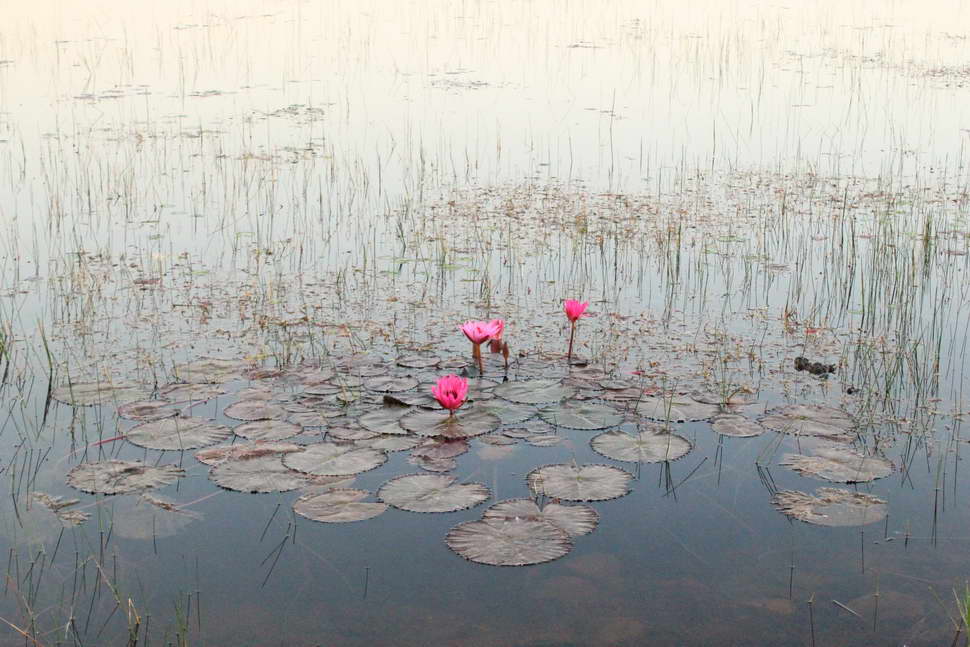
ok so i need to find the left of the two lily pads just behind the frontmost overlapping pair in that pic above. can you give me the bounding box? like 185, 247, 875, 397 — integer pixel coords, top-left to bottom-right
377, 474, 489, 512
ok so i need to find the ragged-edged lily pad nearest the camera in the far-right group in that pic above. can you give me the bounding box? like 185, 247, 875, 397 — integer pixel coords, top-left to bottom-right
771, 488, 889, 527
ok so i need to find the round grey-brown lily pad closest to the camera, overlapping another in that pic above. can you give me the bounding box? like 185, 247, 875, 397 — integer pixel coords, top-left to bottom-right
445, 518, 572, 566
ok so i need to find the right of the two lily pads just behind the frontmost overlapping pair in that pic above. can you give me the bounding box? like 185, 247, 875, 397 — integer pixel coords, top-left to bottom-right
526, 464, 633, 501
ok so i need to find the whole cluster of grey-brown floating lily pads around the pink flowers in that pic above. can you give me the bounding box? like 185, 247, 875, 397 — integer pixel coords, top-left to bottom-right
47, 326, 893, 566
